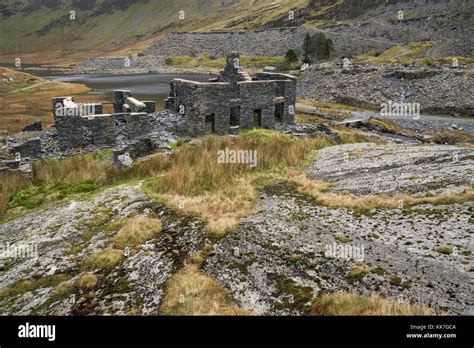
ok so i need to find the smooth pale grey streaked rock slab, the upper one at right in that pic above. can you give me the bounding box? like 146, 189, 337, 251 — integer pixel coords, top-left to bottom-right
306, 143, 474, 195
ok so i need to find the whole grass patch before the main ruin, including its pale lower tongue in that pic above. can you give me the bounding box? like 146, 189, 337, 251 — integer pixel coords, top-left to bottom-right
152, 130, 331, 235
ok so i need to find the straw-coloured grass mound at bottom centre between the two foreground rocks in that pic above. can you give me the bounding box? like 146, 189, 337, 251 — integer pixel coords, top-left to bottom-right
160, 264, 252, 315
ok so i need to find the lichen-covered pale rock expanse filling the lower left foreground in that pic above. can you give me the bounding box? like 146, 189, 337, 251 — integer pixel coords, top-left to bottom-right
0, 186, 204, 315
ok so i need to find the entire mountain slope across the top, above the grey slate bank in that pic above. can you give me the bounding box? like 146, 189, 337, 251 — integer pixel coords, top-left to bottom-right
0, 0, 474, 65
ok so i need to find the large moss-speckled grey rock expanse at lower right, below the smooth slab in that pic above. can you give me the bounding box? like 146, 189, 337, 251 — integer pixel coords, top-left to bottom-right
204, 187, 473, 315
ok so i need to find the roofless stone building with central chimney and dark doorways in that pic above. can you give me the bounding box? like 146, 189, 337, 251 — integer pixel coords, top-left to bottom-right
165, 53, 296, 134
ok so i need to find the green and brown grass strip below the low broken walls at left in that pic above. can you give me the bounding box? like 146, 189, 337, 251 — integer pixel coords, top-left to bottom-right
0, 150, 161, 219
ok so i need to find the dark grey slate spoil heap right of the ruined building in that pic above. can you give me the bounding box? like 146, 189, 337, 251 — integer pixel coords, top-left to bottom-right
298, 61, 474, 116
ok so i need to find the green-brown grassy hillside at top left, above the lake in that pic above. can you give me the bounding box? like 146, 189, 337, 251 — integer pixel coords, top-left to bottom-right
0, 0, 308, 56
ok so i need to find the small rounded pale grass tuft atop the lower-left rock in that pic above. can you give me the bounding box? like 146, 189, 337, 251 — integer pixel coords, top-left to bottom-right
114, 215, 163, 249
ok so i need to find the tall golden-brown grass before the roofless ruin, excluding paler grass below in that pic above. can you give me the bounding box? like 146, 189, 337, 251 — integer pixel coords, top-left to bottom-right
157, 130, 329, 196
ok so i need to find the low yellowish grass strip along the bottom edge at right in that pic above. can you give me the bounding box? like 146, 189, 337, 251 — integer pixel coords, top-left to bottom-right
313, 292, 434, 316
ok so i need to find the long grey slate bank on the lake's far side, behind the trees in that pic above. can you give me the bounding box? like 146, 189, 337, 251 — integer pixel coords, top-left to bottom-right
137, 27, 393, 68
